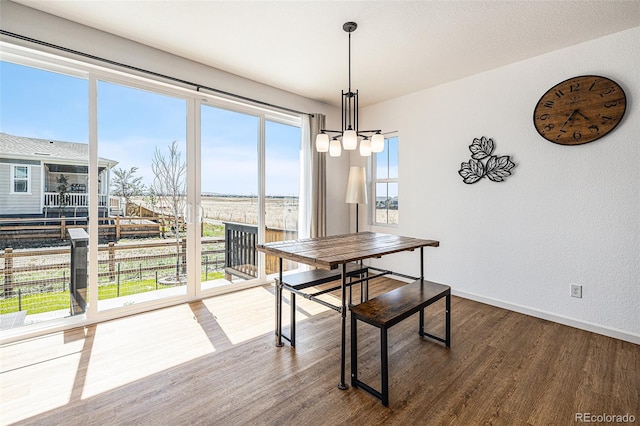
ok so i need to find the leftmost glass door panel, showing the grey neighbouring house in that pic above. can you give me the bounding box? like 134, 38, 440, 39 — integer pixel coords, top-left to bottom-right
0, 58, 90, 332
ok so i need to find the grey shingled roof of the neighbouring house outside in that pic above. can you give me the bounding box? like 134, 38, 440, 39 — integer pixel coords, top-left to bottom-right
0, 133, 118, 167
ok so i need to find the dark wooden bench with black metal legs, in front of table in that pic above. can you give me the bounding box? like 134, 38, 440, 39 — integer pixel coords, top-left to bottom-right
351, 280, 451, 406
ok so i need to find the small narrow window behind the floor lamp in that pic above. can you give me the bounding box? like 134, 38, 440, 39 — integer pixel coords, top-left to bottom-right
373, 135, 399, 225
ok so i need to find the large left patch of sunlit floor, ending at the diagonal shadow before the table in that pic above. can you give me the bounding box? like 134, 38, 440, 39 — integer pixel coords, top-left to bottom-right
0, 304, 215, 424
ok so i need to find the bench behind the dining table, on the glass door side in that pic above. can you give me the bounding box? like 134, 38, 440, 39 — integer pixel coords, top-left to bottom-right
275, 263, 368, 346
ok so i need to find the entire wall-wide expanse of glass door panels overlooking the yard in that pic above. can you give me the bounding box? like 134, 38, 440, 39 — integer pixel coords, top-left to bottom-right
0, 45, 302, 334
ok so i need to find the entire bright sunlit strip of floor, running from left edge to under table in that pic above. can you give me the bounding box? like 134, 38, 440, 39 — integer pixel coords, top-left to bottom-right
0, 286, 337, 424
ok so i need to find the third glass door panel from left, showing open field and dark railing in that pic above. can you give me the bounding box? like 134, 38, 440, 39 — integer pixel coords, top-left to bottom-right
200, 105, 260, 290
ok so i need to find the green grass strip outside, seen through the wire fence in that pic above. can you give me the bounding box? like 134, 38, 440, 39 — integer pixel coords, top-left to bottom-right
0, 272, 224, 315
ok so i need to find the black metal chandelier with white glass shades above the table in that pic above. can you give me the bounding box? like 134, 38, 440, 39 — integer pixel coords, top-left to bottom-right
316, 22, 384, 157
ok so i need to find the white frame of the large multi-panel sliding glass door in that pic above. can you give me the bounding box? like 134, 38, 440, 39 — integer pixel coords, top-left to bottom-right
0, 41, 303, 335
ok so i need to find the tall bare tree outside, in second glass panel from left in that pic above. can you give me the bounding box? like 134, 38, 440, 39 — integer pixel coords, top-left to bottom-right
151, 141, 187, 278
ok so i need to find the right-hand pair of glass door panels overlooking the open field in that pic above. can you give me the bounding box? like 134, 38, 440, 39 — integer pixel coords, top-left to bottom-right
200, 105, 301, 290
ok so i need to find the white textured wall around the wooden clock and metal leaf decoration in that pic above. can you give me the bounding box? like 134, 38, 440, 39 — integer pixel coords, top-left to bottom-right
361, 27, 640, 343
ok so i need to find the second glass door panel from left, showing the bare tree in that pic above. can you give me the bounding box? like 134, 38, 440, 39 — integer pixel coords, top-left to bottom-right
97, 81, 188, 310
